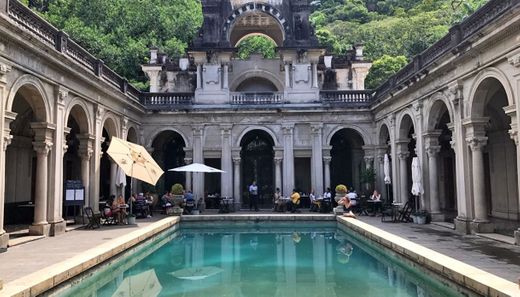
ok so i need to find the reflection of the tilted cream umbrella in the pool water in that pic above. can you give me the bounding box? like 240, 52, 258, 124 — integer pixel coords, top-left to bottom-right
112, 269, 162, 297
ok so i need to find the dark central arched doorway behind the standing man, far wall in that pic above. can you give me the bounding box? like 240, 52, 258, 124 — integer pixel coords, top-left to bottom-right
240, 130, 274, 208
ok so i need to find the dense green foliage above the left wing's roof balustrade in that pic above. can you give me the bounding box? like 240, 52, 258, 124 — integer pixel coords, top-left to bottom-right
26, 0, 202, 87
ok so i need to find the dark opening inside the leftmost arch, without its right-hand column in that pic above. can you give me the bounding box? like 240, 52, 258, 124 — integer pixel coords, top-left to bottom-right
4, 85, 48, 230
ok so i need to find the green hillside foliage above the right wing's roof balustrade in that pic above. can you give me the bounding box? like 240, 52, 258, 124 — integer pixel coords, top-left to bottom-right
311, 0, 487, 88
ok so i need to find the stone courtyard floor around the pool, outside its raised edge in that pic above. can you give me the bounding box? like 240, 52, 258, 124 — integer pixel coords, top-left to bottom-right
0, 210, 520, 295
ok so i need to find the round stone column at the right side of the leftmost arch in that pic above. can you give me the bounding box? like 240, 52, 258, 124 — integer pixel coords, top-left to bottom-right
29, 128, 53, 236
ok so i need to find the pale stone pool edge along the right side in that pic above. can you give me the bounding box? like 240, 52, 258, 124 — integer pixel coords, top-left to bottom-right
337, 216, 520, 297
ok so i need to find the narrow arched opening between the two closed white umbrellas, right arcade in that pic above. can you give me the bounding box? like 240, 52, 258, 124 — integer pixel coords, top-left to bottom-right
395, 114, 416, 207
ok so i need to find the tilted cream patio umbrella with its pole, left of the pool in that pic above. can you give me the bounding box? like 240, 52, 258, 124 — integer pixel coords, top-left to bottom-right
107, 137, 164, 213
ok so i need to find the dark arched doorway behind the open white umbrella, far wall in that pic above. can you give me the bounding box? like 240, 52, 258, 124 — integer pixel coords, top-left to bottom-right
152, 131, 187, 194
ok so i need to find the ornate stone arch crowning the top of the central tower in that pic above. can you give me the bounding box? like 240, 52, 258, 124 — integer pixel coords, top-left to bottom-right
222, 2, 290, 46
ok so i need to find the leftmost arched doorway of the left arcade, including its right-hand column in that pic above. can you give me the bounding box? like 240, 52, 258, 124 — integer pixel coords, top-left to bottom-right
4, 85, 49, 235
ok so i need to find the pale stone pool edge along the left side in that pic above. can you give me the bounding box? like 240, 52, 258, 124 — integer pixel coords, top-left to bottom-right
0, 217, 180, 297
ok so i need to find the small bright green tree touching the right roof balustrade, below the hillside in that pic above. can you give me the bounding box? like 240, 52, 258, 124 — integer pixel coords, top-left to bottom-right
365, 55, 408, 89
